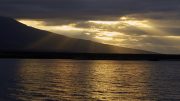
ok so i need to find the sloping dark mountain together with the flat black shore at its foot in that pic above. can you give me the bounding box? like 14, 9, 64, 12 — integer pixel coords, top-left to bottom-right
0, 17, 180, 60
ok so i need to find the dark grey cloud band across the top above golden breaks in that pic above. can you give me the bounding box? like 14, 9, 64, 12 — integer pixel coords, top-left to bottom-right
0, 0, 180, 19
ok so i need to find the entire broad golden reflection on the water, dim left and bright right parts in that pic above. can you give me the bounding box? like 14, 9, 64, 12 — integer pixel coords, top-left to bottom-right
13, 60, 151, 101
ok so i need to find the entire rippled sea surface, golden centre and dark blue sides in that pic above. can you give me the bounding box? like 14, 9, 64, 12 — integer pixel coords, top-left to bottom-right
0, 59, 180, 101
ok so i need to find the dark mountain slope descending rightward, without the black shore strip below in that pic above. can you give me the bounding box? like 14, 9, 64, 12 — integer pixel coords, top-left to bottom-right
0, 17, 152, 54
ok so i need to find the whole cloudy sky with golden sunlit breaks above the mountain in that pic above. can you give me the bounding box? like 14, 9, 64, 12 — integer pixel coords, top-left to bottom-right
0, 0, 180, 54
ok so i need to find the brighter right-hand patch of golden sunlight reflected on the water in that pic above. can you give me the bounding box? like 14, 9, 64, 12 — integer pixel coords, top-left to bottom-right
87, 61, 150, 101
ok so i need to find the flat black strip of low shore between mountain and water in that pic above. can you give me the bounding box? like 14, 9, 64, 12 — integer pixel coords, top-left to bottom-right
0, 52, 180, 61
